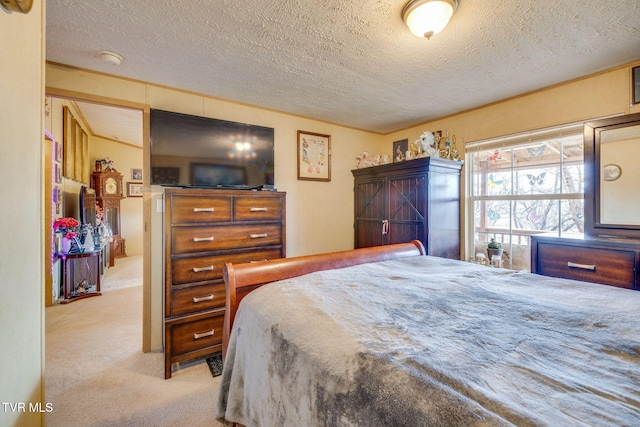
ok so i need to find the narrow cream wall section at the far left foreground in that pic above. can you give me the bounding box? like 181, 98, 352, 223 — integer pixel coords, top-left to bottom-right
0, 1, 46, 426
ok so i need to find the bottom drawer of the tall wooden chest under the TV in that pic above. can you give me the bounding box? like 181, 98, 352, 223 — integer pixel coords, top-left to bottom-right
168, 310, 224, 357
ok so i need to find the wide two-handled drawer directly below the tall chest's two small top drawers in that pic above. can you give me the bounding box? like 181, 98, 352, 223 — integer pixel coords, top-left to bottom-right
171, 224, 282, 254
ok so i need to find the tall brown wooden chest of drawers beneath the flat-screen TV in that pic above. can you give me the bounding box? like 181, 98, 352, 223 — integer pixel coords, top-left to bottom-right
164, 189, 285, 378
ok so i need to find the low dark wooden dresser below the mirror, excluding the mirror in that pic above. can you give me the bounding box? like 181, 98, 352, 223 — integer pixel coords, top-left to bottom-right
531, 234, 640, 290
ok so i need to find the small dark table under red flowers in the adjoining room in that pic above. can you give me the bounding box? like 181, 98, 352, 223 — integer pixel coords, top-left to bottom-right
56, 247, 103, 304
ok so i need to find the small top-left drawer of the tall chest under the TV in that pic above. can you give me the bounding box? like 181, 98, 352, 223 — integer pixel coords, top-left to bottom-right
171, 196, 231, 224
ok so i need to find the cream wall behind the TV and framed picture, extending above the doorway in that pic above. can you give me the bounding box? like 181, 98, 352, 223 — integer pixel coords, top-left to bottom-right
46, 64, 381, 350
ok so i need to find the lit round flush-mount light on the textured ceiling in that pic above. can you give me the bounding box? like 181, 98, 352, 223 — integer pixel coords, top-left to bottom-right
402, 0, 458, 39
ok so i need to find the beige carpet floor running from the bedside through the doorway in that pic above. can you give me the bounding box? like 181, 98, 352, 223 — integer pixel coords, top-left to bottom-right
45, 257, 221, 427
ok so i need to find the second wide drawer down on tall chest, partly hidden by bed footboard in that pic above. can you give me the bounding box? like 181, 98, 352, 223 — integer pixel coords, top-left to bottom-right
171, 249, 282, 285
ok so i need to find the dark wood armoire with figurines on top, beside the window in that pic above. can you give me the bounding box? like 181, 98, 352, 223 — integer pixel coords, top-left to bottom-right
352, 157, 462, 259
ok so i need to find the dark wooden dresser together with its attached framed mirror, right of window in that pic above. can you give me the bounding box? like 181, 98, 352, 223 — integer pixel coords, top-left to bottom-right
531, 113, 640, 290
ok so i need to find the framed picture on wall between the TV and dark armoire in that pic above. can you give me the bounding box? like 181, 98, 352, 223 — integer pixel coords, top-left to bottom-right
298, 130, 331, 181
